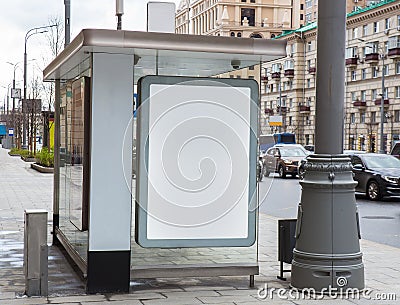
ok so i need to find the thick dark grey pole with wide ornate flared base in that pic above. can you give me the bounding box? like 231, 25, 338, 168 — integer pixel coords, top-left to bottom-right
291, 0, 365, 292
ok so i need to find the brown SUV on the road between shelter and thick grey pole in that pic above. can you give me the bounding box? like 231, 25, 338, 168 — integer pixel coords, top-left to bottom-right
264, 144, 307, 178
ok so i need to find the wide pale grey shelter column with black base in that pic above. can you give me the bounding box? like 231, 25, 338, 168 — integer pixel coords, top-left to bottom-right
87, 53, 133, 293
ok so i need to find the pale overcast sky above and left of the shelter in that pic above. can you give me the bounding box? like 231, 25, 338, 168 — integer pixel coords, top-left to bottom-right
0, 0, 180, 106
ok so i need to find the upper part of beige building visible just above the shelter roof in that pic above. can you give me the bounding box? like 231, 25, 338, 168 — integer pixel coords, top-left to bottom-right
175, 0, 304, 38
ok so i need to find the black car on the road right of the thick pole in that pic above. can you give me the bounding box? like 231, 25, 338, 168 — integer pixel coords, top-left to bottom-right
351, 153, 400, 200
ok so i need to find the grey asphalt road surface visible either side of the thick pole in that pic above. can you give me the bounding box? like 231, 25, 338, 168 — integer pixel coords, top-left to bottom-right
259, 174, 400, 248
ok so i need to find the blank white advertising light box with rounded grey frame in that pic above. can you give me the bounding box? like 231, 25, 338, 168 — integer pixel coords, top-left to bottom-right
135, 76, 258, 248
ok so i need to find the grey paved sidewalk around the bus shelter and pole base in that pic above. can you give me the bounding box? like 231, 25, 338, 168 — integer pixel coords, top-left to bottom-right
0, 148, 400, 305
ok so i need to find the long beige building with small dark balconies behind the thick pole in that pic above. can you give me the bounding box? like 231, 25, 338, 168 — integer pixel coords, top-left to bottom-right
261, 0, 400, 151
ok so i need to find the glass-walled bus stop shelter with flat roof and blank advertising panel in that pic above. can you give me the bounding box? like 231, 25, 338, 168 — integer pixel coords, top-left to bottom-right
44, 29, 286, 293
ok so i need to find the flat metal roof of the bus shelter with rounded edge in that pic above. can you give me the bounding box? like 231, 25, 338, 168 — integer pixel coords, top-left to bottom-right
43, 29, 286, 82
